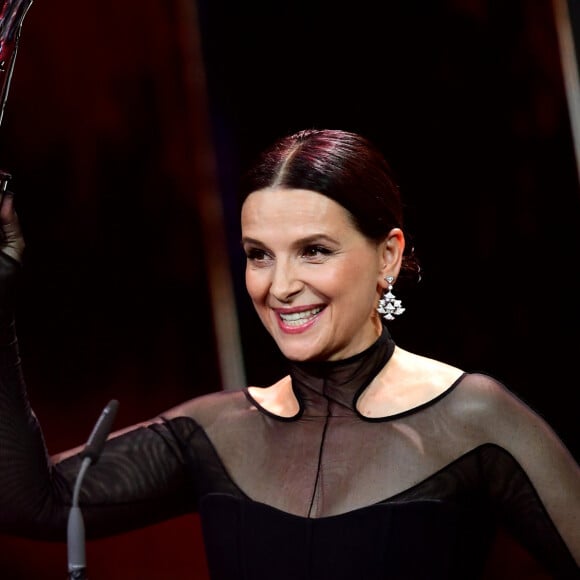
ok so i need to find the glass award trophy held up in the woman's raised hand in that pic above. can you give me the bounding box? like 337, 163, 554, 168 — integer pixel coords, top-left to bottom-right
0, 0, 32, 195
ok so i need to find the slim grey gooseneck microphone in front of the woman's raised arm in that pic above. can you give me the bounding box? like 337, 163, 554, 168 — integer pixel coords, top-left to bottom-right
67, 399, 119, 580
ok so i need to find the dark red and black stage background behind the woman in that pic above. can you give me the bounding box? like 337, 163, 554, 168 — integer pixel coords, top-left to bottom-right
0, 0, 580, 579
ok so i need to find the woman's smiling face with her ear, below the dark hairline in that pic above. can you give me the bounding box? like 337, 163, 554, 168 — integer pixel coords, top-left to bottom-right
241, 188, 404, 361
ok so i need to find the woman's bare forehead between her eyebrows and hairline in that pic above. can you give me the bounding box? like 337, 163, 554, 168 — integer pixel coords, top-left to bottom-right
242, 188, 354, 235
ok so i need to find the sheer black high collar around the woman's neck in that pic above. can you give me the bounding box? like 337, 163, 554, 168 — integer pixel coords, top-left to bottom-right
290, 324, 395, 416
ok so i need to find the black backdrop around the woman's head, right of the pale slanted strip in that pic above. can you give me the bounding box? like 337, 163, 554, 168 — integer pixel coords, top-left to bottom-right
201, 1, 580, 451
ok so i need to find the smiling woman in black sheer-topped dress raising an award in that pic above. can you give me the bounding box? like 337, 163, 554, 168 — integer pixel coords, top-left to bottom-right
0, 130, 580, 580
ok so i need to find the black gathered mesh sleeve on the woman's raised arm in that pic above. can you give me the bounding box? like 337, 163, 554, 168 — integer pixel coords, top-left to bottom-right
0, 249, 202, 540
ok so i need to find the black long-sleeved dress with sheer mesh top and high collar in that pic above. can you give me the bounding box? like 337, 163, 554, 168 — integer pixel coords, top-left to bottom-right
0, 260, 580, 580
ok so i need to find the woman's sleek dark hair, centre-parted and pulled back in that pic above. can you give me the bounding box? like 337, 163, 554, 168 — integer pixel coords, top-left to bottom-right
240, 129, 419, 278
